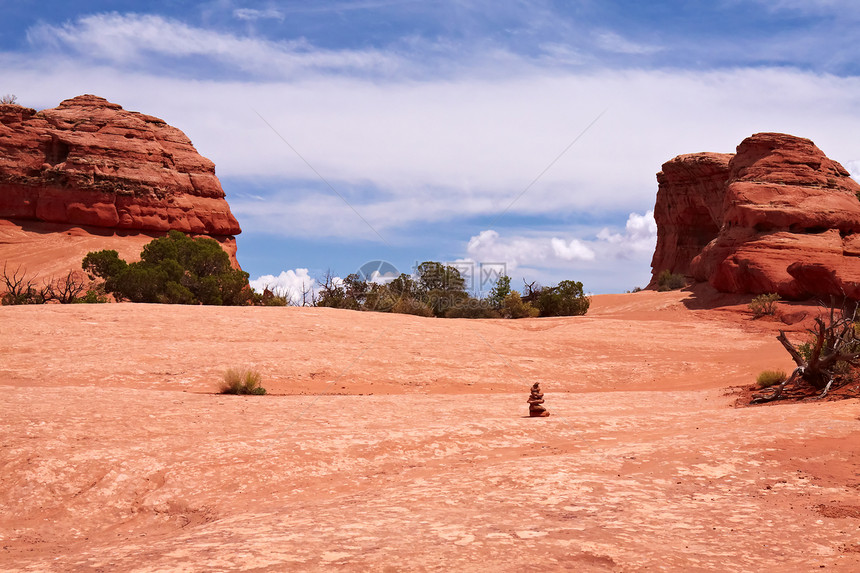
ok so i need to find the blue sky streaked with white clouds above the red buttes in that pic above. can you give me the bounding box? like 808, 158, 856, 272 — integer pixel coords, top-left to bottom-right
0, 0, 860, 293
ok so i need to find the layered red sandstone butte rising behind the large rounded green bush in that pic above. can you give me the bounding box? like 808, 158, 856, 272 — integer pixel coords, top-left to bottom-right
0, 95, 241, 274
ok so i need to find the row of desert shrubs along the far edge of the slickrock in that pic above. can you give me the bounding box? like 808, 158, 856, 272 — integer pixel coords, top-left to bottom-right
0, 231, 591, 318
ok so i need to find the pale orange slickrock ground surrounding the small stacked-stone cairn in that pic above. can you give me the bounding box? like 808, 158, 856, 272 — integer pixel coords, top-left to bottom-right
0, 291, 860, 572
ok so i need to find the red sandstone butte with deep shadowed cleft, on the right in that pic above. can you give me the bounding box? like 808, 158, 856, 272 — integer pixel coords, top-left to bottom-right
649, 133, 860, 300
